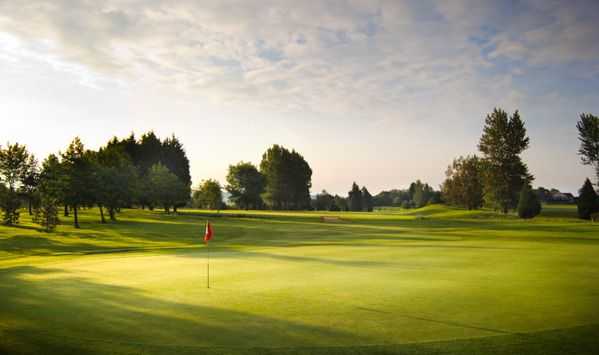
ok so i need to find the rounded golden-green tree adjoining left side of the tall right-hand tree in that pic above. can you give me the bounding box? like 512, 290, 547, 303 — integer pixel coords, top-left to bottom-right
441, 155, 483, 210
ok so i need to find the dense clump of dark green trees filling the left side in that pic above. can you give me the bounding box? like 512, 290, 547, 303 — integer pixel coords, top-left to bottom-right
0, 132, 191, 231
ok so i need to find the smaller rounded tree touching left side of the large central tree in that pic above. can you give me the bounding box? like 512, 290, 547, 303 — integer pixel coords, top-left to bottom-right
225, 162, 266, 209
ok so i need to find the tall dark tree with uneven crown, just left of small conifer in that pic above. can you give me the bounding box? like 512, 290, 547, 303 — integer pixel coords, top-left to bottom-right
478, 108, 533, 213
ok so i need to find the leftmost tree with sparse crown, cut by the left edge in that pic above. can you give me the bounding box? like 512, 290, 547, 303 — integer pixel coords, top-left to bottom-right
0, 143, 31, 225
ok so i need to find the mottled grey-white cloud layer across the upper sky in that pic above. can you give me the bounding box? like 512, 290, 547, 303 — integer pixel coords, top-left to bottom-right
0, 0, 599, 119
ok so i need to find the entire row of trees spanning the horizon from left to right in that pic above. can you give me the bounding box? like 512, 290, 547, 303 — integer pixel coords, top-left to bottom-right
0, 108, 599, 230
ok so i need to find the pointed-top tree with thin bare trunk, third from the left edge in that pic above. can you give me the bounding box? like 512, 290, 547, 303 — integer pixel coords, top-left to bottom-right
62, 137, 94, 228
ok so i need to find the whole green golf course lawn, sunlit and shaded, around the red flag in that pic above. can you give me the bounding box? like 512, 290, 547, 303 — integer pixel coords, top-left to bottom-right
0, 205, 599, 354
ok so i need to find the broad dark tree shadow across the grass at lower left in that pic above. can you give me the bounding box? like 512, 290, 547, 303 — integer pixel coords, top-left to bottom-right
0, 266, 361, 354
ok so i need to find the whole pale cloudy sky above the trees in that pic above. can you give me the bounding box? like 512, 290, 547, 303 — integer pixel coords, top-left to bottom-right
0, 0, 599, 194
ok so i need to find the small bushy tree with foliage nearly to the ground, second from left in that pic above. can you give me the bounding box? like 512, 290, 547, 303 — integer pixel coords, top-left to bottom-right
34, 154, 65, 232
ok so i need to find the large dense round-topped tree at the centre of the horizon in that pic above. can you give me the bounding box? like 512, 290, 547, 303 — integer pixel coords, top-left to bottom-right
260, 144, 312, 209
